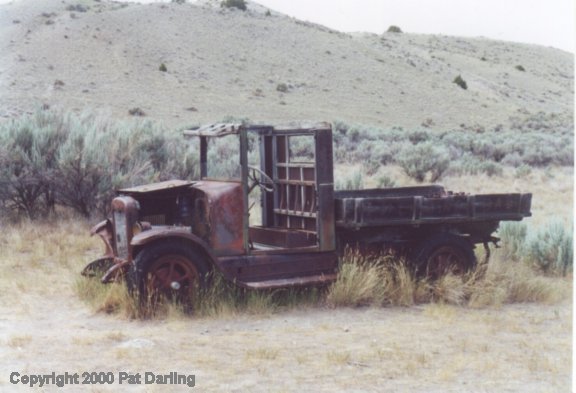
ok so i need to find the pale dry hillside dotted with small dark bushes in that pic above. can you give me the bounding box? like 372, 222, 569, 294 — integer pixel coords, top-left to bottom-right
0, 0, 574, 129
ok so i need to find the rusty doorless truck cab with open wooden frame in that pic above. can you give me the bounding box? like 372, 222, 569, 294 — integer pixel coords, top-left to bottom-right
184, 123, 337, 288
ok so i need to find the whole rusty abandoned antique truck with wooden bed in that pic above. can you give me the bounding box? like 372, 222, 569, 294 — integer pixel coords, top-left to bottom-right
83, 123, 532, 298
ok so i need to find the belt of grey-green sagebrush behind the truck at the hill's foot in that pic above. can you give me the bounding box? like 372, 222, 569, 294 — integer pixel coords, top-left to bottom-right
0, 108, 574, 218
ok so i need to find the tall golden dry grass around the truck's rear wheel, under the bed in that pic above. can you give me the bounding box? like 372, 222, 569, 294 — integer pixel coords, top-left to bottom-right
326, 247, 572, 308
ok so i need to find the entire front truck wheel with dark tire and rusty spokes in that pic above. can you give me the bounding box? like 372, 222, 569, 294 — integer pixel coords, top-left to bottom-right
128, 241, 210, 306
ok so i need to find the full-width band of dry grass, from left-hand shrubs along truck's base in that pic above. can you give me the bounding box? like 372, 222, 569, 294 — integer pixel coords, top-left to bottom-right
0, 207, 572, 320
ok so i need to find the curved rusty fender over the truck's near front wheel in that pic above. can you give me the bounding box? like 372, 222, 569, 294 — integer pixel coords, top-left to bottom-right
130, 227, 217, 265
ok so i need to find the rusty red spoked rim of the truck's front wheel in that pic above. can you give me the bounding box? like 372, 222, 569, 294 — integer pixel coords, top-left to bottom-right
146, 255, 198, 300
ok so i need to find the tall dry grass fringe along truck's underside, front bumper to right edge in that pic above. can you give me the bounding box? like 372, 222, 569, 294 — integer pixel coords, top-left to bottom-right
76, 239, 571, 319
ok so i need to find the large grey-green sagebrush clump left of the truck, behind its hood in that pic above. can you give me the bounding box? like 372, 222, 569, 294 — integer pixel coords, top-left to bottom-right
0, 110, 197, 218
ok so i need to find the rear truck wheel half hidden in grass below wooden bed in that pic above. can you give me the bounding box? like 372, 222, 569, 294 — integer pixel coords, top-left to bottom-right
410, 233, 477, 280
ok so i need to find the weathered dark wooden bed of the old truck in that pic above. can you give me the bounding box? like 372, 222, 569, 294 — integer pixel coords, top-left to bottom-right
334, 186, 532, 228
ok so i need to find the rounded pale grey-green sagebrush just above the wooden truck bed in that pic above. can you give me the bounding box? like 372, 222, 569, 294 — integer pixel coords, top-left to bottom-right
397, 142, 450, 182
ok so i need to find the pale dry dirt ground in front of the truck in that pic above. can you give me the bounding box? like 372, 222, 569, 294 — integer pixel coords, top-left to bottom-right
0, 278, 572, 393
